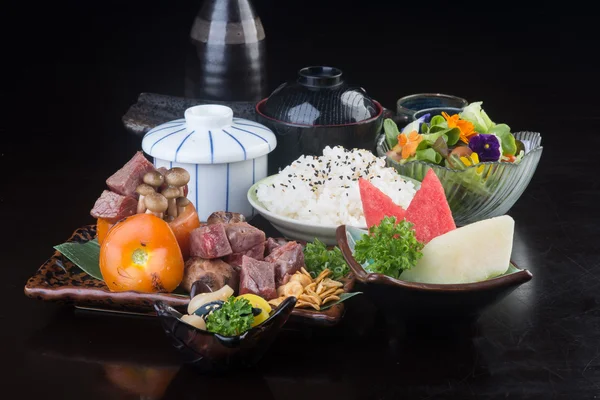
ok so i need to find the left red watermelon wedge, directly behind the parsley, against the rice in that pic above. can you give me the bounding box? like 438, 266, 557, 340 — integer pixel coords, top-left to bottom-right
358, 178, 406, 229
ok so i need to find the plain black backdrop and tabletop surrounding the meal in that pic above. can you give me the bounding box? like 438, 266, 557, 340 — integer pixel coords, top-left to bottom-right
0, 0, 600, 399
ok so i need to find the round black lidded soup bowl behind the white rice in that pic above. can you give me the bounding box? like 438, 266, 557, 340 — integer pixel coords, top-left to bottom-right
256, 66, 383, 174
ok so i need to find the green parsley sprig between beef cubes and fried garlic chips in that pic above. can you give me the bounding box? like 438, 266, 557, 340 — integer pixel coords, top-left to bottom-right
304, 239, 350, 280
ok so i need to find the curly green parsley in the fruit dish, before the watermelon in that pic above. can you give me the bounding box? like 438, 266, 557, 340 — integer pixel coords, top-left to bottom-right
354, 217, 424, 278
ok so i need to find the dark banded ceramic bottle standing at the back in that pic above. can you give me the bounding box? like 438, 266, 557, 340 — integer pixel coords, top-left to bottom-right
185, 0, 267, 101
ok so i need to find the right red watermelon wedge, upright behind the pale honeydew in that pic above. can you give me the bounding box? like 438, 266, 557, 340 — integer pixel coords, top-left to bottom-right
406, 169, 456, 243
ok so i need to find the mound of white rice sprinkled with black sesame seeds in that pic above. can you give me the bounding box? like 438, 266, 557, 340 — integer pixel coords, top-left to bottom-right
256, 146, 415, 227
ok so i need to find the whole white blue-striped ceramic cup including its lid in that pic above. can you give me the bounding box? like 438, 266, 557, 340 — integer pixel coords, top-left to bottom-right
142, 104, 277, 221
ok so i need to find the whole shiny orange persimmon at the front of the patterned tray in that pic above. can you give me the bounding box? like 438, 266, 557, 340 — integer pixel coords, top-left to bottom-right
100, 214, 183, 293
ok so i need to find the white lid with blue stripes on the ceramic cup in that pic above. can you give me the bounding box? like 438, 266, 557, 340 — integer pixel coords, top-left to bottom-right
142, 104, 277, 164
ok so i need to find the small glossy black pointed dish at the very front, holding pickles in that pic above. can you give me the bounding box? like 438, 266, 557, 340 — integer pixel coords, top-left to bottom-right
154, 297, 296, 372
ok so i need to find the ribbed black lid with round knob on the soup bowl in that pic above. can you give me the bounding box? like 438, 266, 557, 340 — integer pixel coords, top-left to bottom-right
261, 67, 379, 125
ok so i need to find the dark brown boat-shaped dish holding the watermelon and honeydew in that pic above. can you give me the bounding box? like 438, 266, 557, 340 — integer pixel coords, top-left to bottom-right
336, 225, 533, 321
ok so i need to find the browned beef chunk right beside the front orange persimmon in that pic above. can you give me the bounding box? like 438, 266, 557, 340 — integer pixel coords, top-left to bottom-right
181, 257, 240, 292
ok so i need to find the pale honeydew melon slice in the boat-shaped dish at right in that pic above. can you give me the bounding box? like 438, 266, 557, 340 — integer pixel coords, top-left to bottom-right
400, 215, 515, 284
